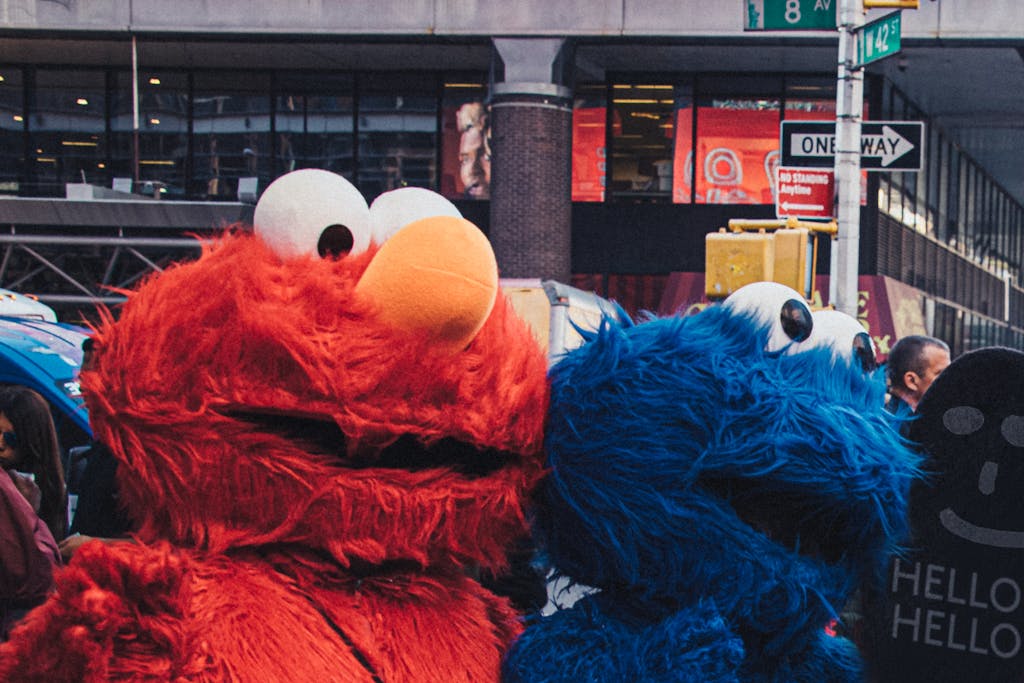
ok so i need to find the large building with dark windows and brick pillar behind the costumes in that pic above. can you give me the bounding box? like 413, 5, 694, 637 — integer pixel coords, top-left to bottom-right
0, 0, 1024, 353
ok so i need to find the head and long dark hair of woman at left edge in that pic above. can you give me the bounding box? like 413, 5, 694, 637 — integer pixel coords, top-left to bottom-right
0, 386, 68, 543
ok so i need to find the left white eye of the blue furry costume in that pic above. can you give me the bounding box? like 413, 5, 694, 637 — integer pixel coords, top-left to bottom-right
724, 283, 814, 351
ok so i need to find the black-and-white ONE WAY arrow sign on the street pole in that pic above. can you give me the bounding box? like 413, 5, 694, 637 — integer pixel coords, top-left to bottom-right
779, 121, 925, 171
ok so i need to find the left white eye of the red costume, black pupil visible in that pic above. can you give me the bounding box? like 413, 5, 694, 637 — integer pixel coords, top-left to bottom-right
253, 168, 370, 258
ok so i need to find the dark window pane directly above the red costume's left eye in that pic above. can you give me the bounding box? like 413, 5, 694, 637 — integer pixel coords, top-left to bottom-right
274, 74, 355, 180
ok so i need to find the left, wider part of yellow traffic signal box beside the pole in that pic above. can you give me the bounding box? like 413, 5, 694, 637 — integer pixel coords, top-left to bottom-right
705, 227, 775, 299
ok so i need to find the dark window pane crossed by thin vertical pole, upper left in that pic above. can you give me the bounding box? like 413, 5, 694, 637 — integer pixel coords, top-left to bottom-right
111, 72, 188, 198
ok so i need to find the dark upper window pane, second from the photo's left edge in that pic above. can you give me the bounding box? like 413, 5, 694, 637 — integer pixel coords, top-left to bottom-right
29, 70, 108, 197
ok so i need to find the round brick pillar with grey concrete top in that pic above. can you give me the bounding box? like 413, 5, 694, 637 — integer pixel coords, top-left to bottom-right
489, 38, 572, 283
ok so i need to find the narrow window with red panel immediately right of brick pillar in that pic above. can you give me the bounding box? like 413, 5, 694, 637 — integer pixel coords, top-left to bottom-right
572, 84, 608, 202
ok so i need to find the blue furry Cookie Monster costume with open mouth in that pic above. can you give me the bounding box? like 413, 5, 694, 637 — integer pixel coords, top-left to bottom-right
503, 284, 918, 683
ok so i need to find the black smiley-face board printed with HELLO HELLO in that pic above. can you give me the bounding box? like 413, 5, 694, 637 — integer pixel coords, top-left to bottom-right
863, 347, 1024, 683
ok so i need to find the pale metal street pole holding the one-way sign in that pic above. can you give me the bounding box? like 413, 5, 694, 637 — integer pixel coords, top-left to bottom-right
828, 0, 864, 317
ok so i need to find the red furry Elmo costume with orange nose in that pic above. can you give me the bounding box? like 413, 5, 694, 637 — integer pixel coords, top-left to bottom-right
0, 170, 547, 683
